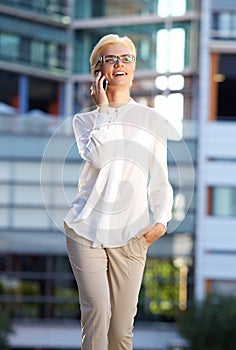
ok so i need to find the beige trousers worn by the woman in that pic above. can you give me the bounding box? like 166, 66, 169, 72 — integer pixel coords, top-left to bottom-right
67, 232, 147, 350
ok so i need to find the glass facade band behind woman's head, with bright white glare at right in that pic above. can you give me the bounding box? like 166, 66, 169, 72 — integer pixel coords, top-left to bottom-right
74, 22, 196, 74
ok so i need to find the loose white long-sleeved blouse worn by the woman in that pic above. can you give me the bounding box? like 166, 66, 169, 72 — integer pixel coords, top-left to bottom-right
64, 99, 173, 247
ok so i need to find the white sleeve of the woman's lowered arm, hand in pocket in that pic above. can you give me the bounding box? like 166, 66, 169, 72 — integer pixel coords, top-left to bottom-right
148, 117, 173, 226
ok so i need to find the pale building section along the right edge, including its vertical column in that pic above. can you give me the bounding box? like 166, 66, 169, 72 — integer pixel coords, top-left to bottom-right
195, 1, 236, 298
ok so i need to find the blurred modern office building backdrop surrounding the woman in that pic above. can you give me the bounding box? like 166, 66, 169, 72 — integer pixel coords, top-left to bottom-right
0, 0, 236, 350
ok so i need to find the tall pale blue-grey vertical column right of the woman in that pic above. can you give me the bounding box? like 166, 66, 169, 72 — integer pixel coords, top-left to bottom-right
194, 0, 211, 299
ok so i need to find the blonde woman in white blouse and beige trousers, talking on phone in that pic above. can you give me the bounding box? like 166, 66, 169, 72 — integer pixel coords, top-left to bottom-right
64, 34, 172, 350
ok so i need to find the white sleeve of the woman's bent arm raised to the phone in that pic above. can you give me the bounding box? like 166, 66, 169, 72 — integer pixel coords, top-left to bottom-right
73, 112, 122, 169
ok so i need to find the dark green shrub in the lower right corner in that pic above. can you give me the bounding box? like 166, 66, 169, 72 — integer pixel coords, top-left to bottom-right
178, 295, 236, 350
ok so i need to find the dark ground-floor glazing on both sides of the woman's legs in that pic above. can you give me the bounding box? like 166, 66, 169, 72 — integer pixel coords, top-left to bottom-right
0, 254, 193, 321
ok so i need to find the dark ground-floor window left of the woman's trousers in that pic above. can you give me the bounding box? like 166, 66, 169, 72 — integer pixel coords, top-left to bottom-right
0, 255, 79, 319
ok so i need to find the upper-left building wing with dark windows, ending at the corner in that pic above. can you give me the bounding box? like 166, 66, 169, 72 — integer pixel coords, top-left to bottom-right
0, 0, 70, 115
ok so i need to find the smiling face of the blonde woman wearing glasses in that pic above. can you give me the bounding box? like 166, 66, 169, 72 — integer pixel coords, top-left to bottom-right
100, 44, 135, 87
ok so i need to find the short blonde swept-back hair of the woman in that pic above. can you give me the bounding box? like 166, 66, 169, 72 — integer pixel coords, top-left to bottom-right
90, 34, 136, 75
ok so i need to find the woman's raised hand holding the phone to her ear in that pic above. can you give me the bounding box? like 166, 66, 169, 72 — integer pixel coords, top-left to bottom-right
90, 71, 108, 108
